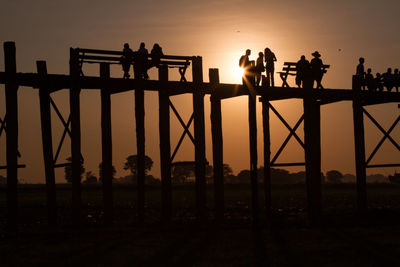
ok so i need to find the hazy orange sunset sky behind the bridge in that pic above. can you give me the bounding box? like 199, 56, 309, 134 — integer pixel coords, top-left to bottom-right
0, 0, 400, 182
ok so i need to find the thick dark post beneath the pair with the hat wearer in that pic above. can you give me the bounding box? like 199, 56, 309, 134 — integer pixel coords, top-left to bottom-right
303, 87, 321, 225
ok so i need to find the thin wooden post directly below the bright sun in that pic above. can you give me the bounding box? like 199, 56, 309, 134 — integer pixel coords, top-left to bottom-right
249, 92, 259, 226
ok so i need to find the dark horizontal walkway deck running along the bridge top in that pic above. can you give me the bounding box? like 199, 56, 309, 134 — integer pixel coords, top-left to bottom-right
0, 72, 400, 105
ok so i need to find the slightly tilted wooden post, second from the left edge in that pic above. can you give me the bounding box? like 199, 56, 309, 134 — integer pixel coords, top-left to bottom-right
36, 61, 57, 225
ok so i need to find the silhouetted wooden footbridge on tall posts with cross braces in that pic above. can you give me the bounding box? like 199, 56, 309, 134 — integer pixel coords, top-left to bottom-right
0, 42, 400, 229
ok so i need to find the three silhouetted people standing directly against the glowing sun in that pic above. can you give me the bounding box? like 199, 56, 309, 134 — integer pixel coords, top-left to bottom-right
239, 47, 276, 86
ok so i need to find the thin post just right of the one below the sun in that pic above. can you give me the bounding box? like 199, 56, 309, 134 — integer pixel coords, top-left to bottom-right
261, 97, 272, 219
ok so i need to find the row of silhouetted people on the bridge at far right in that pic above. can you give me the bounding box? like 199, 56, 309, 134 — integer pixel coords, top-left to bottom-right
356, 57, 400, 92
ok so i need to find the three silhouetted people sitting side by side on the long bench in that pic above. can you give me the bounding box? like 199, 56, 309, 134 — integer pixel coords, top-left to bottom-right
121, 42, 164, 80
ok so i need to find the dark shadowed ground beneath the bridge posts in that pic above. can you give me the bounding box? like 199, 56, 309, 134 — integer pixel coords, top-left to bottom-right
0, 185, 400, 266
